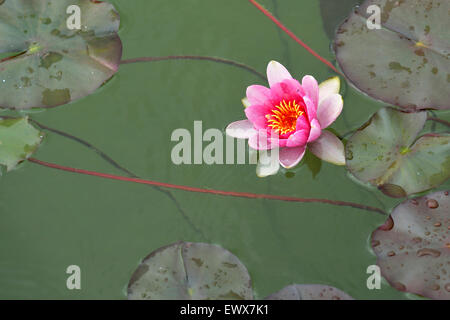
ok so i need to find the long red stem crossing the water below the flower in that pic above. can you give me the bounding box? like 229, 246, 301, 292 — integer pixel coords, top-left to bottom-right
28, 158, 386, 215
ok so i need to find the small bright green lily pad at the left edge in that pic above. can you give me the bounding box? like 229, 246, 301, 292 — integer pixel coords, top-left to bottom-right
0, 118, 43, 171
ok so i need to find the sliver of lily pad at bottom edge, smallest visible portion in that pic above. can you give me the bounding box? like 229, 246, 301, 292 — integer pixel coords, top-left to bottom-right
265, 284, 353, 300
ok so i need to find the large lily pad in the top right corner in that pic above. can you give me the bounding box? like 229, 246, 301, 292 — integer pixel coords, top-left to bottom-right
333, 0, 450, 109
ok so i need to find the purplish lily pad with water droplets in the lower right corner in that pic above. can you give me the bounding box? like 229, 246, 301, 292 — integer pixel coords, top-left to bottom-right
372, 191, 450, 300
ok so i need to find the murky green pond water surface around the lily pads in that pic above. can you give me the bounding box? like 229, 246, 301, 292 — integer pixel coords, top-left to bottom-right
0, 0, 450, 299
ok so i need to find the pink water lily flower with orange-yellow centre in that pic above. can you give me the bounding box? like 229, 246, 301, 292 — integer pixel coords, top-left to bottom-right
226, 61, 345, 176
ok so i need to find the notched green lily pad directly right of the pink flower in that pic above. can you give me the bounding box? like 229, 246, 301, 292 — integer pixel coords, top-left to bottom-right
346, 108, 450, 198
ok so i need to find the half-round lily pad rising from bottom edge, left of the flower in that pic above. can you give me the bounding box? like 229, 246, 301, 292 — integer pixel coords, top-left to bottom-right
128, 242, 253, 300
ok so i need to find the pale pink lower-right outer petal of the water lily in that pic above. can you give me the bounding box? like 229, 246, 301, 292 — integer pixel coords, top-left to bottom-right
308, 131, 345, 166
